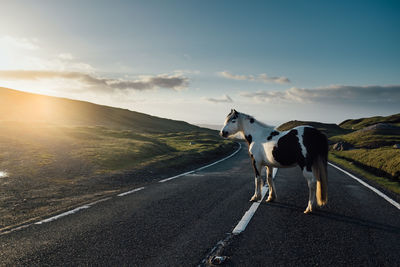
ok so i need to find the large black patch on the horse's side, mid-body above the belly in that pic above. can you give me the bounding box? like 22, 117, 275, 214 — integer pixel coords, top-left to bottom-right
272, 130, 305, 169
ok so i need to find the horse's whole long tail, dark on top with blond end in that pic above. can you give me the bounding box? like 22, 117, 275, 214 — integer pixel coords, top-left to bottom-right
312, 133, 328, 206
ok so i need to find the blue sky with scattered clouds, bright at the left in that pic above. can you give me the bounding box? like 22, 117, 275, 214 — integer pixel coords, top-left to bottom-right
0, 0, 400, 125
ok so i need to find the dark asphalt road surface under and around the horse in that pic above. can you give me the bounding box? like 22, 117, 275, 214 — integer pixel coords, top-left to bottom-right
0, 148, 400, 266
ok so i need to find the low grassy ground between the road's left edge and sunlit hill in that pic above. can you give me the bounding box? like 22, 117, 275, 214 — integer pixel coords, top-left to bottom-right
0, 123, 235, 229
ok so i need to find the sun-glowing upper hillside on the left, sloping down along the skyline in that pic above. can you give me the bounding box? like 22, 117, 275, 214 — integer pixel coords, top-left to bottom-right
0, 87, 200, 133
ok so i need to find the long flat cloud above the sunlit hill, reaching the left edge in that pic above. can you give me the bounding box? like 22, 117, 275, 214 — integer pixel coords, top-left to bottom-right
0, 70, 189, 91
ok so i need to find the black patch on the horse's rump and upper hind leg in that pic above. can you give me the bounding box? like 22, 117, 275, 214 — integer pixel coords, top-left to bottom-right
303, 127, 328, 171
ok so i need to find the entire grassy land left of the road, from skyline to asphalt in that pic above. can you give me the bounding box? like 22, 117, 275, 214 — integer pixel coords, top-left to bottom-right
0, 88, 236, 232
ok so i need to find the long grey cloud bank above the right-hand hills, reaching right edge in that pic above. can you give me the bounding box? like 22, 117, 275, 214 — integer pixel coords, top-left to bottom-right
240, 85, 400, 104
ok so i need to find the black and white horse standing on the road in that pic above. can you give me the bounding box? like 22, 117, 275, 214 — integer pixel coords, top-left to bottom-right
220, 109, 328, 214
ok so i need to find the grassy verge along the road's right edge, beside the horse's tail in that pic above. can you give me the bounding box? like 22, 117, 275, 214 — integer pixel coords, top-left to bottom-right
329, 151, 400, 194
